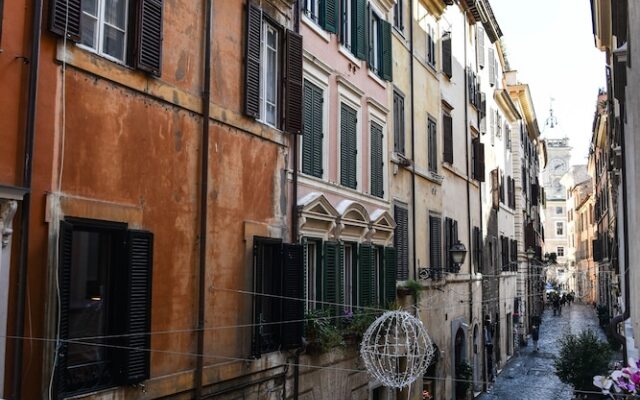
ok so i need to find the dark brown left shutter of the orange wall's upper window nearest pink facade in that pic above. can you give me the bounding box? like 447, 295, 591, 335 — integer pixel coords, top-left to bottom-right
244, 5, 262, 118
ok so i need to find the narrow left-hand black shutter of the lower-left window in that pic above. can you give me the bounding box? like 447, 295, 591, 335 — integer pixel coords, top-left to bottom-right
55, 221, 73, 393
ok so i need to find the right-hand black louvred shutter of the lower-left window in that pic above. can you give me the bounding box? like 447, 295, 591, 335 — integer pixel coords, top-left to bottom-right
122, 230, 153, 384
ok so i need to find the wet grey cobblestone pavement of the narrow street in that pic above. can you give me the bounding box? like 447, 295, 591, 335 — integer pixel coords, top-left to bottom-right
477, 303, 606, 400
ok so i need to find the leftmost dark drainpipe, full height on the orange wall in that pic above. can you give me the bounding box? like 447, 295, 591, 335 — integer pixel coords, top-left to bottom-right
11, 0, 42, 400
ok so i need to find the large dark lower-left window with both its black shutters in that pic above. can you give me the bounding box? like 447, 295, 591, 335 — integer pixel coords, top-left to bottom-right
56, 218, 153, 397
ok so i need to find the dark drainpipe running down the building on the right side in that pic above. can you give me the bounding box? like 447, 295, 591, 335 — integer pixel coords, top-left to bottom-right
609, 107, 631, 365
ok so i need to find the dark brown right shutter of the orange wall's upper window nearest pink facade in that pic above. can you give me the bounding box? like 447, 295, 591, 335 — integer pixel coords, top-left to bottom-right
285, 30, 302, 134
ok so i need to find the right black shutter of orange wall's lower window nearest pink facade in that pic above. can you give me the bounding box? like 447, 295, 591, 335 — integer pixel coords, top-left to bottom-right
280, 244, 305, 348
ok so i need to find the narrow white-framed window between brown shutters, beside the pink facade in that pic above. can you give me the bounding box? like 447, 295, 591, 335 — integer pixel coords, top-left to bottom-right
258, 19, 282, 129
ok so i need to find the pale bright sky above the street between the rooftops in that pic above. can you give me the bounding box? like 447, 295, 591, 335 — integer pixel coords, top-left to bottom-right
490, 0, 606, 164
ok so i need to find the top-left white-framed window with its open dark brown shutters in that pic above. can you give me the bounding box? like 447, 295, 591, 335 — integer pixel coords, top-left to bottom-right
49, 0, 163, 76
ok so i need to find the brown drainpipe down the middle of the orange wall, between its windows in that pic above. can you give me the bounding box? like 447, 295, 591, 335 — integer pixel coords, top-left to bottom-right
194, 0, 213, 400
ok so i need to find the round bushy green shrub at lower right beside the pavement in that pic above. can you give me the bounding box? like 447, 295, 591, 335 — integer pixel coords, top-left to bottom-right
554, 329, 611, 391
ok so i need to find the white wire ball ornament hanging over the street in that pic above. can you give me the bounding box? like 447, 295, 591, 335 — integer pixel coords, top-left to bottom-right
360, 310, 434, 389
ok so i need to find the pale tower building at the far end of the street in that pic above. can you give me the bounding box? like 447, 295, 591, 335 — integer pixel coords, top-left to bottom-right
542, 107, 571, 268
